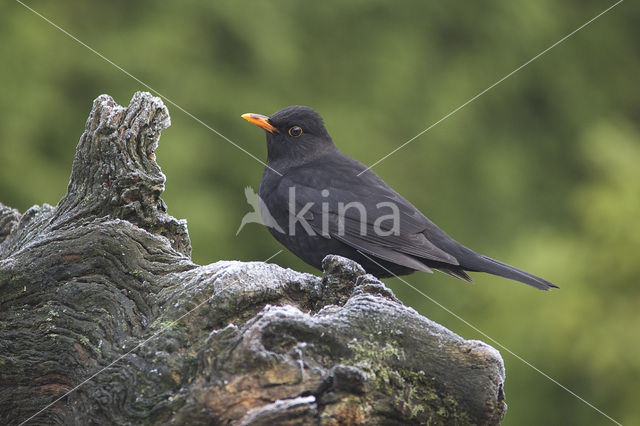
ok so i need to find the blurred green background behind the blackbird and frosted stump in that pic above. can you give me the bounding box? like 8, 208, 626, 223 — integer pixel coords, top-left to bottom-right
0, 0, 640, 425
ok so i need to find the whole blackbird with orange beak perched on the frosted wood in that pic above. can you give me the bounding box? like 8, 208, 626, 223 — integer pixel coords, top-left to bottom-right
242, 106, 557, 290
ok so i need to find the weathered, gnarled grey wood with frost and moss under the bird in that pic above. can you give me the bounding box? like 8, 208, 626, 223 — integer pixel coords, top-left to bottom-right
0, 93, 506, 425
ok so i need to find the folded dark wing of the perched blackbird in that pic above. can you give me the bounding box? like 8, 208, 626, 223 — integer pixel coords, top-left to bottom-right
276, 153, 459, 269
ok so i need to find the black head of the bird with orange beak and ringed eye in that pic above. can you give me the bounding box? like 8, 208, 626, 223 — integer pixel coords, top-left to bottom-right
242, 105, 334, 165
